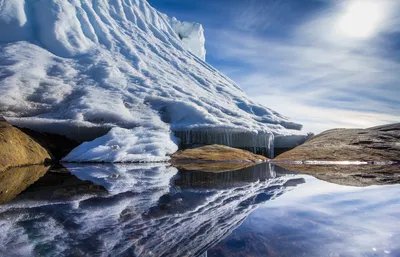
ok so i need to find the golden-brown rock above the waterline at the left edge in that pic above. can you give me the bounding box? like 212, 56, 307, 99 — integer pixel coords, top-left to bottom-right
0, 121, 52, 171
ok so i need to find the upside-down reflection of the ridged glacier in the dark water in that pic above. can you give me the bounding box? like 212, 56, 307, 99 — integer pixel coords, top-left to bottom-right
0, 164, 304, 256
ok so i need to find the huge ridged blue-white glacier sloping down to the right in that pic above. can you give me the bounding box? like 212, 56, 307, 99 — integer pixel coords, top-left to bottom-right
0, 0, 306, 162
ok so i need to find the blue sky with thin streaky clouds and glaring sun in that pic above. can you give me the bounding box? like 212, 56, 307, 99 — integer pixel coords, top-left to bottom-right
149, 0, 400, 132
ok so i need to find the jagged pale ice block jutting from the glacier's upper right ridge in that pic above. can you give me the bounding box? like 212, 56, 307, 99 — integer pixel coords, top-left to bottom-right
170, 17, 206, 61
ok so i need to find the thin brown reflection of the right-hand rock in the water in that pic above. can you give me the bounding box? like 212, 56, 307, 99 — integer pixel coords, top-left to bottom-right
279, 164, 400, 187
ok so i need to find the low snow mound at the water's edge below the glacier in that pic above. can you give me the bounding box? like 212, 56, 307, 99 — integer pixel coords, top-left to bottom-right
63, 127, 178, 162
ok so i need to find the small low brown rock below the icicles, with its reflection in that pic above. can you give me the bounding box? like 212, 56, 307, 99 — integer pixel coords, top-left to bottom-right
171, 145, 268, 172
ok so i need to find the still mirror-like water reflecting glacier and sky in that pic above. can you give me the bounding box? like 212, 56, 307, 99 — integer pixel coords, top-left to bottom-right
0, 164, 400, 257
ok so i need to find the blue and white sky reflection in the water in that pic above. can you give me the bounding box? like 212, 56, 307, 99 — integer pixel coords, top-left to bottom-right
208, 176, 400, 257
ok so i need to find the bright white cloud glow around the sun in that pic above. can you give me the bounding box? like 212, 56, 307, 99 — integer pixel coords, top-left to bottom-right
294, 0, 400, 44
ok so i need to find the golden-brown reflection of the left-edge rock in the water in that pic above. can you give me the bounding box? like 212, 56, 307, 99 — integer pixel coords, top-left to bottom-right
0, 165, 50, 204
